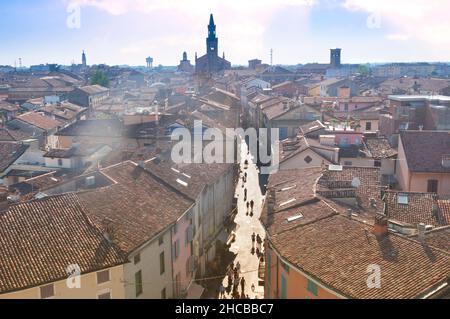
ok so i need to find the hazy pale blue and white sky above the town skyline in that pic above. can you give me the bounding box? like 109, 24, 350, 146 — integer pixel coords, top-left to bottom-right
0, 0, 450, 65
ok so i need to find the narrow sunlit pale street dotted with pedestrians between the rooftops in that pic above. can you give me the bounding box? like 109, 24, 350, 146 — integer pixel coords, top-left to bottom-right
219, 143, 264, 299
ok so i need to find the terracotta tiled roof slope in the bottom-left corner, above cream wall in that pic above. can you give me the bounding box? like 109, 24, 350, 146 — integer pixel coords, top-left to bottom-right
0, 194, 126, 293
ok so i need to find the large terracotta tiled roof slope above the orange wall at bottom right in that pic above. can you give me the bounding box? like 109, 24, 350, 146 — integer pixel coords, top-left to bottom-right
270, 215, 450, 299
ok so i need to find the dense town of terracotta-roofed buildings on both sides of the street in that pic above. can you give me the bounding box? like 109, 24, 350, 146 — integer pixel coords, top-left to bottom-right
0, 15, 450, 298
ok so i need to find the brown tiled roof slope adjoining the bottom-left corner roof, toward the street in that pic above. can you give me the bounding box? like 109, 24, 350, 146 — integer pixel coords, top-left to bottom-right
78, 161, 193, 253
